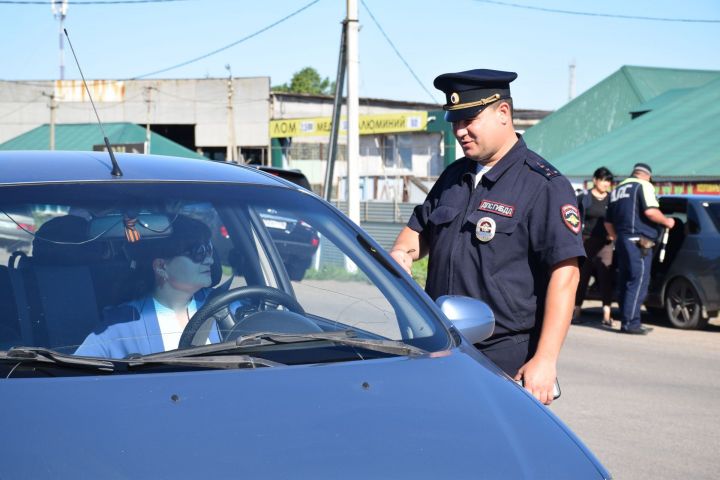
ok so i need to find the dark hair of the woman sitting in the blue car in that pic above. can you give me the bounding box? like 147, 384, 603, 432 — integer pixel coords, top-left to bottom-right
122, 215, 210, 300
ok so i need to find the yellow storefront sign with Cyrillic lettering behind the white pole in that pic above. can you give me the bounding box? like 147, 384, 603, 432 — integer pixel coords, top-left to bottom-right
270, 112, 427, 138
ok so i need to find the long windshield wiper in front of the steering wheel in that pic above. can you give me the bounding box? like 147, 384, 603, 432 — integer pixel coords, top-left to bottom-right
139, 330, 427, 360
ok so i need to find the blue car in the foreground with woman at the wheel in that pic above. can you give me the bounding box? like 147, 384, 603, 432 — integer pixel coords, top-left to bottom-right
0, 152, 610, 479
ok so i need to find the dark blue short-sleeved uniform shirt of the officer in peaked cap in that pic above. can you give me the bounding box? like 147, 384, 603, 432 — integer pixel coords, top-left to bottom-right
408, 138, 585, 337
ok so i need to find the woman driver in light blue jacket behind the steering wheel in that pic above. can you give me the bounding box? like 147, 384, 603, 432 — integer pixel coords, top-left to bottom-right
75, 215, 220, 358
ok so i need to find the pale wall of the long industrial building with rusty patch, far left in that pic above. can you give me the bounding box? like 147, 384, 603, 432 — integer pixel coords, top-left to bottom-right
0, 77, 270, 148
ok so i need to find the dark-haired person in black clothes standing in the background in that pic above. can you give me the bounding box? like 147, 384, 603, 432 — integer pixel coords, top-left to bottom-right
573, 167, 613, 326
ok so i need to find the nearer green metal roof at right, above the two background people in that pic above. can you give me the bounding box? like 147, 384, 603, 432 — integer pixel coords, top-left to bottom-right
552, 78, 720, 180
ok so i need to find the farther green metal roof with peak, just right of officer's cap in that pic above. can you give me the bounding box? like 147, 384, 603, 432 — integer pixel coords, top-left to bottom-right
523, 66, 720, 161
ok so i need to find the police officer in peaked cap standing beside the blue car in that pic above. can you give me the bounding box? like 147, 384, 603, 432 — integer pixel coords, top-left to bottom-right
390, 69, 585, 404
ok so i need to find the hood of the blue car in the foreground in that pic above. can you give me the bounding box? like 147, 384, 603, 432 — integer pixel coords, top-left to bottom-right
0, 349, 608, 479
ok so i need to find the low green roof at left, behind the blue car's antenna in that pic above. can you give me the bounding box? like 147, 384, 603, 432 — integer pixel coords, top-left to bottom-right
0, 123, 204, 158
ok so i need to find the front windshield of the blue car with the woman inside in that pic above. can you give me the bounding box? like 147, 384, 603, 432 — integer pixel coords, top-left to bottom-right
0, 182, 450, 370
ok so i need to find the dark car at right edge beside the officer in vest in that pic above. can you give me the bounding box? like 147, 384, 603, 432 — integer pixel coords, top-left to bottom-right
645, 195, 720, 329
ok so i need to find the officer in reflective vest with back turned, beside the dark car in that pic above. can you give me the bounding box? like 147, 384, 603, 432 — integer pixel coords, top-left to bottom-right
605, 163, 675, 335
